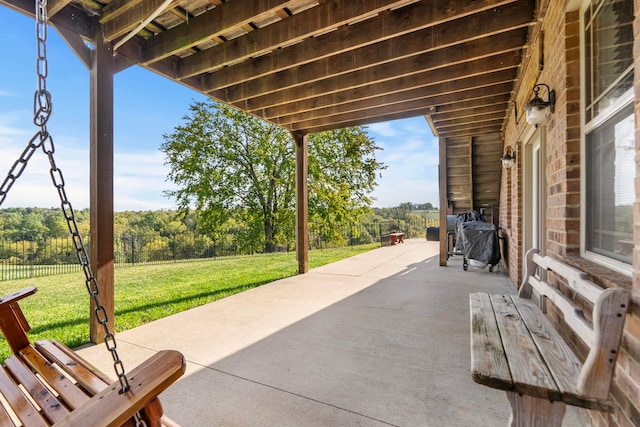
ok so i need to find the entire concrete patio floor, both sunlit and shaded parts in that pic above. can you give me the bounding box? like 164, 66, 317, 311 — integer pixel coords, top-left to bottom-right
78, 239, 582, 427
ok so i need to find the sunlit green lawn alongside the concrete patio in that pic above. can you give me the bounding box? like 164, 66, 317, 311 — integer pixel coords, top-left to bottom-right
0, 243, 379, 360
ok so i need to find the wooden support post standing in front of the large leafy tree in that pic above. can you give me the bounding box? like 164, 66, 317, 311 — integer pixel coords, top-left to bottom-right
292, 132, 309, 274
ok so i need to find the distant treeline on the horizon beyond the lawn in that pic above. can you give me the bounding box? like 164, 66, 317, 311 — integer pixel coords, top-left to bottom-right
0, 205, 437, 281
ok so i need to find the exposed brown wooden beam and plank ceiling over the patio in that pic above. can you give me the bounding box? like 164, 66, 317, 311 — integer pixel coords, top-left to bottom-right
0, 0, 536, 211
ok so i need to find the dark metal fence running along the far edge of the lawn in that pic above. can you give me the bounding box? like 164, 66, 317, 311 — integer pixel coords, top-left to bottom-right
0, 218, 433, 281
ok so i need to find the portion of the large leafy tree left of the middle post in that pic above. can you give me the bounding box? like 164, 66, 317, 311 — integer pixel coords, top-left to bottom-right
162, 102, 294, 252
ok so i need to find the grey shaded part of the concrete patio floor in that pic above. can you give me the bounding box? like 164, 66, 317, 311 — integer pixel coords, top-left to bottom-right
162, 247, 513, 426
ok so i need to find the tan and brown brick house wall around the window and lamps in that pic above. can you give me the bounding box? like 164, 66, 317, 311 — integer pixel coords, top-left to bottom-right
500, 0, 640, 427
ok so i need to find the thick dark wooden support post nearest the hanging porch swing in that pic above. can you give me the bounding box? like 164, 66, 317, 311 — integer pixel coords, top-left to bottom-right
89, 31, 114, 343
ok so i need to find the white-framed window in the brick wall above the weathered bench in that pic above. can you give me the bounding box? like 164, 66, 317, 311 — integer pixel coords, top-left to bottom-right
582, 0, 636, 265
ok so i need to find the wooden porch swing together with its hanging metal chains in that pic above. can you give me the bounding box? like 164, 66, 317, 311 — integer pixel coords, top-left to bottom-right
0, 0, 185, 427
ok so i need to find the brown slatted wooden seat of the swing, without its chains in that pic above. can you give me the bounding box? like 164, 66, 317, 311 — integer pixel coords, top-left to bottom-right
0, 287, 185, 427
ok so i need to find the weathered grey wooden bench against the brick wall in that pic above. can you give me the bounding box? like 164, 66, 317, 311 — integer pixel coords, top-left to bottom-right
470, 249, 629, 426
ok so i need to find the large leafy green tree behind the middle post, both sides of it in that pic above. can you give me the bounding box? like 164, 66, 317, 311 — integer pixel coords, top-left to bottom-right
161, 101, 384, 252
